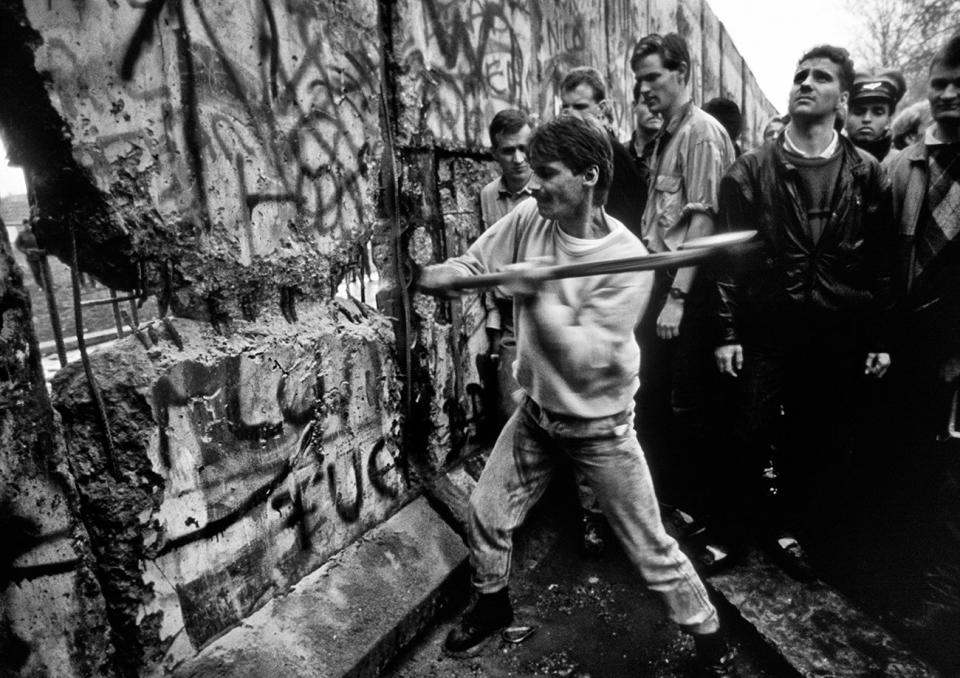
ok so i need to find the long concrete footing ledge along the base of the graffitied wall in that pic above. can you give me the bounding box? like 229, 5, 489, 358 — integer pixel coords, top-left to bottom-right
174, 497, 467, 678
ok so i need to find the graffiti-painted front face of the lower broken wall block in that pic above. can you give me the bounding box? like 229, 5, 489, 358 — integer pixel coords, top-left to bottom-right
141, 322, 407, 646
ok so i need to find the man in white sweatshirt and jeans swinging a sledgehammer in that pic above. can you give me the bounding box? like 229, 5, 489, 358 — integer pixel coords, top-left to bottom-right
419, 116, 732, 676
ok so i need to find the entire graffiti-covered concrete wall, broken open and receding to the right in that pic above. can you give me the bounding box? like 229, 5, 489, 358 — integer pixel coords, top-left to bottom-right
0, 0, 770, 676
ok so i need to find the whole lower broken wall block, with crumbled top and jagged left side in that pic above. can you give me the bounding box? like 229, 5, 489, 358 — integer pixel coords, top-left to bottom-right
54, 304, 411, 675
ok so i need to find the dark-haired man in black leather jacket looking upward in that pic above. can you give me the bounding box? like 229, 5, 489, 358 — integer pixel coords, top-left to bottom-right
715, 45, 893, 579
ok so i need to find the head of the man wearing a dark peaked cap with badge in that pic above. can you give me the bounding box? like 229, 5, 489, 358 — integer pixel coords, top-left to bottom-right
846, 71, 907, 162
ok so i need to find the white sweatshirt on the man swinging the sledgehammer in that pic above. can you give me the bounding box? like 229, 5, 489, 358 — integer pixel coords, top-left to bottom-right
443, 200, 653, 419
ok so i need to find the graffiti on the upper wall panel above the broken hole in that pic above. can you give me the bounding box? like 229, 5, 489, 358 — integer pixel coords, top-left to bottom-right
30, 0, 380, 302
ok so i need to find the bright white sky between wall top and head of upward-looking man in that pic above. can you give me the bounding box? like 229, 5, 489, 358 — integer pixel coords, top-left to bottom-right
707, 0, 858, 113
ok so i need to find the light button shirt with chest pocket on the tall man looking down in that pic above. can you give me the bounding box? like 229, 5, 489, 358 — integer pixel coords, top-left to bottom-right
643, 102, 735, 252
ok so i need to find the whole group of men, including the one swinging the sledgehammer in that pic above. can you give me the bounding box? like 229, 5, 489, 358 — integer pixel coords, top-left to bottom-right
420, 27, 960, 675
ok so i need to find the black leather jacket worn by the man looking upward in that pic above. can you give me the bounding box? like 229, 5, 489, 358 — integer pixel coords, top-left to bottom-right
717, 133, 894, 350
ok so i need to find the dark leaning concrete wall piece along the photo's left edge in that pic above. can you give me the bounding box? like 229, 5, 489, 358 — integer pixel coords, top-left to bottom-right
0, 223, 113, 677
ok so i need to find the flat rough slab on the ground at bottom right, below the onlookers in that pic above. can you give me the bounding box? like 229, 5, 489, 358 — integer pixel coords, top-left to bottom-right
709, 552, 939, 678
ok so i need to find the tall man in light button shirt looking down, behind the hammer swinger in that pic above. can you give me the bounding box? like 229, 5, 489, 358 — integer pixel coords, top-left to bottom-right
630, 33, 735, 566
